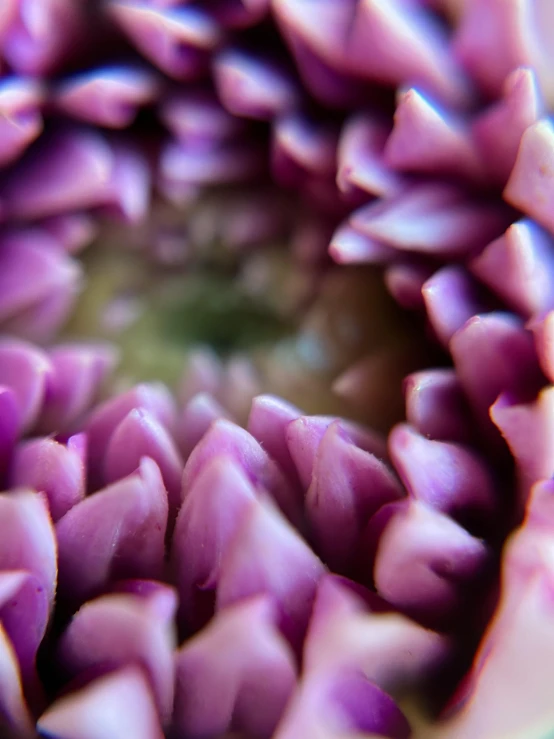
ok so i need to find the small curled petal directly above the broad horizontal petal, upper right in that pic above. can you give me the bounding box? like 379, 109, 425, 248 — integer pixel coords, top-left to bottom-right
337, 113, 405, 197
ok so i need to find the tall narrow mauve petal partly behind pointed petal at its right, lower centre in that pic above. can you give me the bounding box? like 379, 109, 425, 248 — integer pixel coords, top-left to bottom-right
171, 451, 256, 628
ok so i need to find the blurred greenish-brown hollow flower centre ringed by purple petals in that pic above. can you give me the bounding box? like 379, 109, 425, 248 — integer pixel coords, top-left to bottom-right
61, 191, 422, 428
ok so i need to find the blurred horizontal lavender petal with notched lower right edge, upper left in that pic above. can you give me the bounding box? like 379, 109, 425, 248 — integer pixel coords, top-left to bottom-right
54, 66, 158, 128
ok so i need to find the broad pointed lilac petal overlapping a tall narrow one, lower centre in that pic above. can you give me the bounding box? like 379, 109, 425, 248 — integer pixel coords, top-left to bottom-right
217, 498, 325, 650
